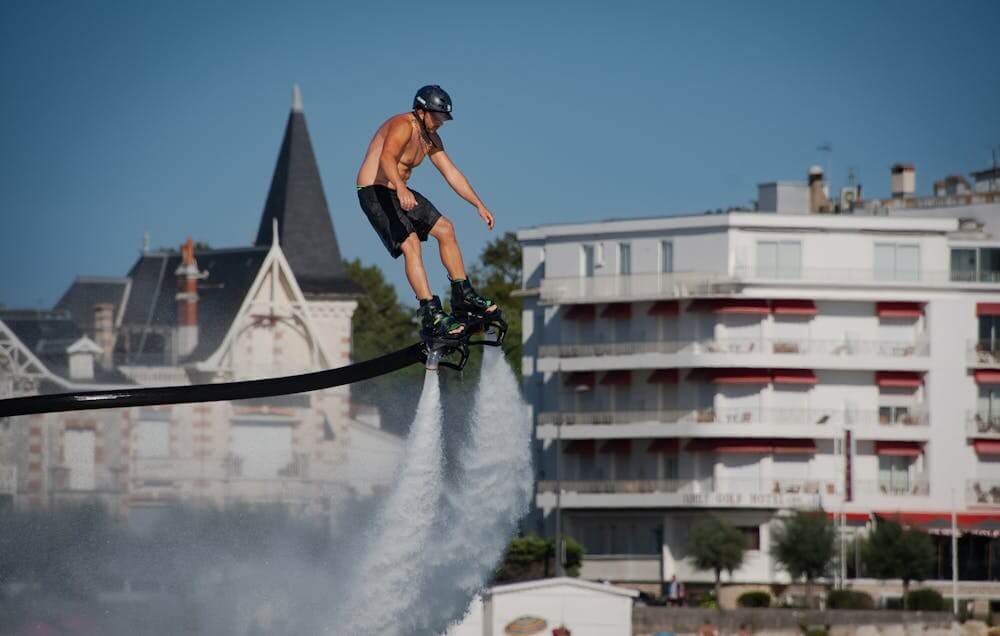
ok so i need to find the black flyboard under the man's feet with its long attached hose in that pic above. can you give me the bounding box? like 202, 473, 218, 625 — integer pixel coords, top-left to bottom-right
0, 310, 507, 418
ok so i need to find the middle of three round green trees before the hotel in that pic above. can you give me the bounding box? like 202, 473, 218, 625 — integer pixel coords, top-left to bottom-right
771, 510, 835, 607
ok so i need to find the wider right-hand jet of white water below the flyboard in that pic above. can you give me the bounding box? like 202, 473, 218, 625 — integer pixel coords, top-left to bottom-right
404, 348, 534, 634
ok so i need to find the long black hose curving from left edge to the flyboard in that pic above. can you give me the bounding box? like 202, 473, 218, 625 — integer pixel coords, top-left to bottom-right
0, 343, 425, 417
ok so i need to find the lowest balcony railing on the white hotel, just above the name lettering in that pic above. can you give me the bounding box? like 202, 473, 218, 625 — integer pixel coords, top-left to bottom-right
538, 477, 841, 495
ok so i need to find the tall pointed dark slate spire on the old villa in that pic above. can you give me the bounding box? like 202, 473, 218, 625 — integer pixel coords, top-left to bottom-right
254, 85, 361, 296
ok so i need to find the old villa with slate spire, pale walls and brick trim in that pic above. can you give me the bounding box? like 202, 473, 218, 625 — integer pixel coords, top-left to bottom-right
0, 88, 402, 524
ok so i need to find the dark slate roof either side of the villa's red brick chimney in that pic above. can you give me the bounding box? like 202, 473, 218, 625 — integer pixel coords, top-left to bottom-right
122, 247, 267, 360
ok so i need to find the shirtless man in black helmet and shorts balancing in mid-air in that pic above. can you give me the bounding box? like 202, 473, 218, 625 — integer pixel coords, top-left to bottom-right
357, 86, 499, 337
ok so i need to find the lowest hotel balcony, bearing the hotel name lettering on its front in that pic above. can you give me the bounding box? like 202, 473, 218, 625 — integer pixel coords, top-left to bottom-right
537, 477, 842, 509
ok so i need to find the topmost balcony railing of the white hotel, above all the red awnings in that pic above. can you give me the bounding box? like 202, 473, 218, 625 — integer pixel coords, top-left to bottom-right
539, 265, 1000, 302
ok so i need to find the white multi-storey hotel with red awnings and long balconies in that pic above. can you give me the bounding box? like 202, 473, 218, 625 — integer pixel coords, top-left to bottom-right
518, 166, 1000, 584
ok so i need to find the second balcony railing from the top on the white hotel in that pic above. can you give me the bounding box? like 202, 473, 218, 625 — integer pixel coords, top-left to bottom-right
538, 338, 930, 358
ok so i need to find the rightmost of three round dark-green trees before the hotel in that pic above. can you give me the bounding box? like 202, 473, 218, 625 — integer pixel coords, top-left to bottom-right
861, 519, 936, 609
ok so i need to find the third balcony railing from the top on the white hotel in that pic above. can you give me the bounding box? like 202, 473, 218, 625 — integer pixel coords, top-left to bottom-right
538, 407, 929, 427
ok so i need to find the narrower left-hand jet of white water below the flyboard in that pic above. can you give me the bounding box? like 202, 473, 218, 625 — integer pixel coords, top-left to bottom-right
336, 371, 443, 634
